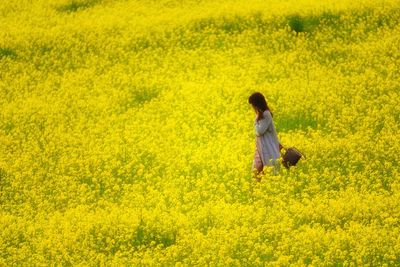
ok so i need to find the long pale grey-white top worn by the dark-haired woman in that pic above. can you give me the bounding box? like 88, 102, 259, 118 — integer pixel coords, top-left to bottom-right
254, 110, 280, 166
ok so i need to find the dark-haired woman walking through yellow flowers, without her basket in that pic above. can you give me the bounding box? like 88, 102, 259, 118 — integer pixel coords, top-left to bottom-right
249, 92, 282, 181
